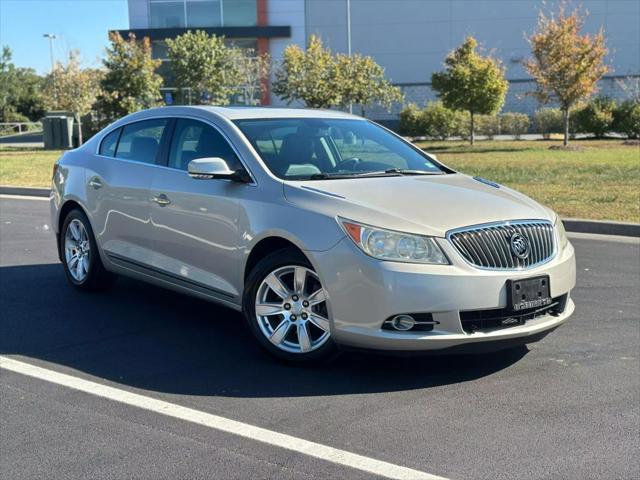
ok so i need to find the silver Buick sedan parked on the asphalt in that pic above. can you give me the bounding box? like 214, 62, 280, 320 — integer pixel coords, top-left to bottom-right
51, 107, 576, 362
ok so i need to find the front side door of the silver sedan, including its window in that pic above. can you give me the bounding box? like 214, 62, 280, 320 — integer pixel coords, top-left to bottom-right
151, 118, 246, 302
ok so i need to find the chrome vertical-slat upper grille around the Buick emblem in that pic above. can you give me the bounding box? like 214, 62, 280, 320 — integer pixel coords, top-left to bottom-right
448, 221, 555, 270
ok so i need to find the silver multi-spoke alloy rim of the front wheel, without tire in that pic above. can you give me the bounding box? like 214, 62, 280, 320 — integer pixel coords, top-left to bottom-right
255, 265, 331, 353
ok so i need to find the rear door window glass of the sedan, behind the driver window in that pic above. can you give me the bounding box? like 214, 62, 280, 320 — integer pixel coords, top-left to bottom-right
116, 119, 168, 163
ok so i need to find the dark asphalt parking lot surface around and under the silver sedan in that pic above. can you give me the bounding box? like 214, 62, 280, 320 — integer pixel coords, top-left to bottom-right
0, 197, 640, 479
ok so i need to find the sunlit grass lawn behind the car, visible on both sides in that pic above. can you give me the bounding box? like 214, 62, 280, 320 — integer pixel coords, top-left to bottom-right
0, 140, 640, 223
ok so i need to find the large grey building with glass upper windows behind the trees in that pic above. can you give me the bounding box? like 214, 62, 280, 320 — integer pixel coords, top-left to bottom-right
112, 0, 640, 120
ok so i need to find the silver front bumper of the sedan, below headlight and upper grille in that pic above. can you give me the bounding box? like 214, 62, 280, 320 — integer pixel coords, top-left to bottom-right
313, 234, 576, 351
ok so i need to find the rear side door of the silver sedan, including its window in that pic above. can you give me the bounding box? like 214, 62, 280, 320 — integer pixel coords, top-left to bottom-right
86, 119, 171, 265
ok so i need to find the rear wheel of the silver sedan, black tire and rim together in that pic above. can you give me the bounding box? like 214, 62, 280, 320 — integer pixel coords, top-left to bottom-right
60, 209, 116, 292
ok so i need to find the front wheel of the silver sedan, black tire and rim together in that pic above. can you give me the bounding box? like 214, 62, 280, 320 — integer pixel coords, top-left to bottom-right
243, 249, 337, 364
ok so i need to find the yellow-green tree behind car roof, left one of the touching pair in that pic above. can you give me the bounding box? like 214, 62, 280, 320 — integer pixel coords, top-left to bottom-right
273, 35, 341, 108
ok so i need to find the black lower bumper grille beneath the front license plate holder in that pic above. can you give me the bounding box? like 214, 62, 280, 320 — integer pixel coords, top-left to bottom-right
460, 294, 568, 333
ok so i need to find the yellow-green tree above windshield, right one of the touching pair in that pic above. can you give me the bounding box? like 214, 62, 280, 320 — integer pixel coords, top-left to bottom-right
336, 54, 402, 117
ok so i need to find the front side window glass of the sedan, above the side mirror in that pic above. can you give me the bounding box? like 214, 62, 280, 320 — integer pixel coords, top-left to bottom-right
168, 118, 241, 171
